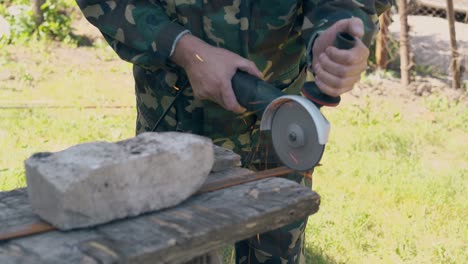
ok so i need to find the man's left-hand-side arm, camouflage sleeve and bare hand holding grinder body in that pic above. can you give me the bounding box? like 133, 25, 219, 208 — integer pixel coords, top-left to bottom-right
76, 0, 261, 112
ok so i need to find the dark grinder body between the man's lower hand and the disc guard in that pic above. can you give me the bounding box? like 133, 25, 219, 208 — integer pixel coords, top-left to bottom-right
231, 71, 284, 117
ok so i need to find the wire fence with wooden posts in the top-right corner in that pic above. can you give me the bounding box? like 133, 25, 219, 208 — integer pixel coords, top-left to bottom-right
375, 0, 468, 88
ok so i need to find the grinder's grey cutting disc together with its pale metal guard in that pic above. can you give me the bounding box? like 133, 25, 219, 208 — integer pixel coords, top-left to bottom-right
260, 95, 330, 171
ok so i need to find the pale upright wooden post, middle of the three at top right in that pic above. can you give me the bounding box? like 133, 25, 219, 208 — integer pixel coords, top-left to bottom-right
398, 0, 410, 86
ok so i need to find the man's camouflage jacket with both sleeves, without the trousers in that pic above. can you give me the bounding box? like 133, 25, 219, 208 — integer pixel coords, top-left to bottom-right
77, 0, 393, 89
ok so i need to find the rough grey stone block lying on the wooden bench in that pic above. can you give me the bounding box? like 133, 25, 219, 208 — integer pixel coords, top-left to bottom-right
25, 132, 214, 230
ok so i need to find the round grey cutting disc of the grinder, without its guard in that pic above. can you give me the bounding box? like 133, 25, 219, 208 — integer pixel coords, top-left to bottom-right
271, 101, 325, 171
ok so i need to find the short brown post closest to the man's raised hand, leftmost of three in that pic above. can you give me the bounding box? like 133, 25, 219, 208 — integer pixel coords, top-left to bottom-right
375, 10, 391, 70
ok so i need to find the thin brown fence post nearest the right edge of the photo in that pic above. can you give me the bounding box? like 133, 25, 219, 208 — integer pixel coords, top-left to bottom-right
447, 0, 461, 89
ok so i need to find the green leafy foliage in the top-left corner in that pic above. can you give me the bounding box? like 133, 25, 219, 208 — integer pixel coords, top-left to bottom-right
0, 0, 75, 44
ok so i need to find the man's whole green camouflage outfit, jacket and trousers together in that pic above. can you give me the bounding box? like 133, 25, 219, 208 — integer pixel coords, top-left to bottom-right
77, 0, 393, 263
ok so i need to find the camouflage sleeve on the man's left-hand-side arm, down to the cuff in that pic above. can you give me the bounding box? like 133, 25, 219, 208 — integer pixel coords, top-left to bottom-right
76, 0, 188, 68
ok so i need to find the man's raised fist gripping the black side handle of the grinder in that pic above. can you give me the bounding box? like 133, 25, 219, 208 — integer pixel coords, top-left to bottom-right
312, 18, 369, 96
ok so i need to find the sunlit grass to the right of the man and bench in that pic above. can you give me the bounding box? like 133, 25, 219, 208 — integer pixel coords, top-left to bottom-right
307, 96, 468, 263
